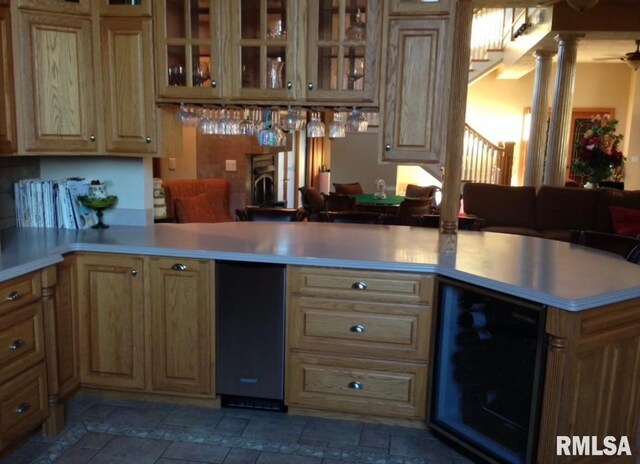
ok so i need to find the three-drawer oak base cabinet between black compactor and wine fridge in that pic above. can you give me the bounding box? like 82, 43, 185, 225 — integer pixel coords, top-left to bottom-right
286, 267, 433, 420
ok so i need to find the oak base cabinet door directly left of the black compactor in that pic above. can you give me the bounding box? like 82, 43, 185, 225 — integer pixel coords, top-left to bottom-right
150, 258, 213, 394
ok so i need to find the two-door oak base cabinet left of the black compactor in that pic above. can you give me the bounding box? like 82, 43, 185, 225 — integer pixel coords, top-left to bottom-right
77, 254, 215, 398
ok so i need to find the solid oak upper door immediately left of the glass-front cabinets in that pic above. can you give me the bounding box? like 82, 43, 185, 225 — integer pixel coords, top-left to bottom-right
101, 18, 157, 153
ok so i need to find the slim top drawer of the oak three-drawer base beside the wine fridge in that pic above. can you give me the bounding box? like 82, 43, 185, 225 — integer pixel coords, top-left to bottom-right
288, 266, 433, 304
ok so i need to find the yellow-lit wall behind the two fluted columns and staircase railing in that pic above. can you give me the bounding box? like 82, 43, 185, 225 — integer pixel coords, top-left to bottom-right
466, 63, 636, 184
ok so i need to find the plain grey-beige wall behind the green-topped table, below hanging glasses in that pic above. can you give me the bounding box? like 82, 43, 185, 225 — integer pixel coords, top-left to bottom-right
330, 131, 397, 194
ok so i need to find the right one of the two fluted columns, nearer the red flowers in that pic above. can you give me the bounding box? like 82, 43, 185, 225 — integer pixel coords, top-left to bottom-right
544, 34, 583, 187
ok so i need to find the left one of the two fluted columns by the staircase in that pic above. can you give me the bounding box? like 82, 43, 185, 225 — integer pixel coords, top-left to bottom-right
524, 50, 556, 188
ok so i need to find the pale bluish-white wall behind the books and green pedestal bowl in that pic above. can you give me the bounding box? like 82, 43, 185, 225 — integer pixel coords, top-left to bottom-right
40, 156, 153, 225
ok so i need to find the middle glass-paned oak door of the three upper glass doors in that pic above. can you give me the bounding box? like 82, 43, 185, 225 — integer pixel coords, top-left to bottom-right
231, 0, 297, 101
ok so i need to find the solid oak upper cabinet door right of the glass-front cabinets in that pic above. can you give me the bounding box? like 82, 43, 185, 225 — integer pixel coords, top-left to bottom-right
381, 19, 450, 164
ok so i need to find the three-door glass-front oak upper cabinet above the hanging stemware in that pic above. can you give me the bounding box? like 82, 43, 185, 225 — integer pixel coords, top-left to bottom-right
155, 0, 382, 106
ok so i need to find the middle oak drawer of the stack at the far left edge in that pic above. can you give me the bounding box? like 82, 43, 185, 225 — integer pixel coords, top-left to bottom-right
0, 302, 44, 379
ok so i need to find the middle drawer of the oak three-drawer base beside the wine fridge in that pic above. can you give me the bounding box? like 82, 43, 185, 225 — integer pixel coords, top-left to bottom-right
288, 297, 431, 362
